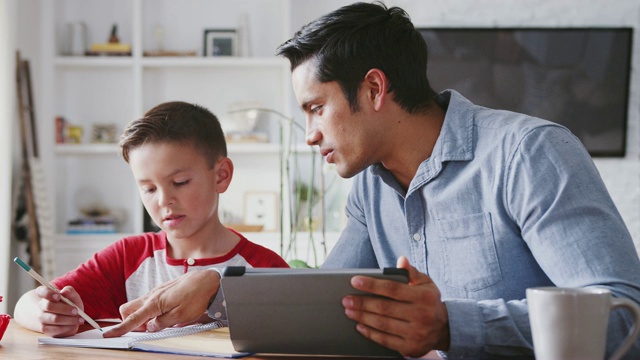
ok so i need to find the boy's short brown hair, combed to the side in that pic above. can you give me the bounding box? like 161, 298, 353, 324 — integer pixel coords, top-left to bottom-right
118, 101, 227, 167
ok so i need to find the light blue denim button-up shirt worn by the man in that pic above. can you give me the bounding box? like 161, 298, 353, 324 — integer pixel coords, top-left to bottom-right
323, 91, 640, 359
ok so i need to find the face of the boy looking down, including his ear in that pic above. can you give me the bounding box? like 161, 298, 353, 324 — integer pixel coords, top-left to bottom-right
129, 142, 233, 240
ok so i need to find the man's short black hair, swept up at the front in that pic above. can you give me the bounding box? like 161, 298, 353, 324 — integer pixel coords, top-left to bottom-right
276, 2, 436, 113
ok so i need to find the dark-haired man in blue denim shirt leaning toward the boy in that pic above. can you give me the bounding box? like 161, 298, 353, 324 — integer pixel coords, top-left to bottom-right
105, 3, 640, 359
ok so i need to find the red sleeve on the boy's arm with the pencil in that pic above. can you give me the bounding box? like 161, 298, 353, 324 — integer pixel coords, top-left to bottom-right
52, 233, 160, 319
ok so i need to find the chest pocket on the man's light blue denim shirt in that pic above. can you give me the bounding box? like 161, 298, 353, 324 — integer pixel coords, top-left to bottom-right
437, 213, 502, 291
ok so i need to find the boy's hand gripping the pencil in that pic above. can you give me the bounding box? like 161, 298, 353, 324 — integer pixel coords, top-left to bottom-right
36, 286, 84, 337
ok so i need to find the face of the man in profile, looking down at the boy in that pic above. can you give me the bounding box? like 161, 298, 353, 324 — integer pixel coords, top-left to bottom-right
292, 60, 376, 178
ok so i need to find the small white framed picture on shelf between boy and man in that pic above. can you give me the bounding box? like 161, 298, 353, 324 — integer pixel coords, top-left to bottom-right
244, 191, 279, 231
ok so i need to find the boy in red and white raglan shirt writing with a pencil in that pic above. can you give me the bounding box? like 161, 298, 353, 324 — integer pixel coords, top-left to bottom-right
14, 102, 288, 337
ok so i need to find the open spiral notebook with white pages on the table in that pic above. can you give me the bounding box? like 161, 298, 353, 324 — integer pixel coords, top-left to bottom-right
38, 321, 250, 358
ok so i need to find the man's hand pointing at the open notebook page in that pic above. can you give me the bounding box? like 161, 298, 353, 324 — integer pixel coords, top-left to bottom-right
103, 270, 220, 338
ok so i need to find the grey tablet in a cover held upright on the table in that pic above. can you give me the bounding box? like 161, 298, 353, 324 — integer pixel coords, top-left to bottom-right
221, 267, 408, 357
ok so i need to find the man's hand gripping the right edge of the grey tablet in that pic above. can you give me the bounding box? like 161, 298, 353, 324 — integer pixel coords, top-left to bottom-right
342, 256, 449, 357
